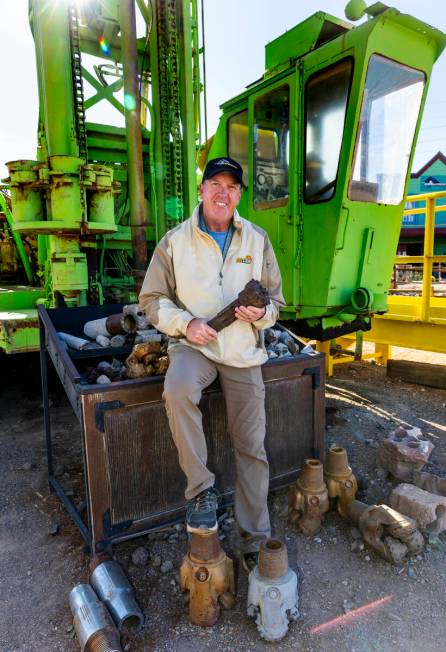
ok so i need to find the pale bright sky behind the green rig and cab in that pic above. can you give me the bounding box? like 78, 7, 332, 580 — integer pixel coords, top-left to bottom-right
0, 0, 446, 178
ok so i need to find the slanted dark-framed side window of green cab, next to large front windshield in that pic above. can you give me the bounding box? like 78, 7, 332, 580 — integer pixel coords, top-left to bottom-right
304, 59, 353, 204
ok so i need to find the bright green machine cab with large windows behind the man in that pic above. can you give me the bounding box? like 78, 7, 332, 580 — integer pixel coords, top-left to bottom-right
210, 3, 446, 341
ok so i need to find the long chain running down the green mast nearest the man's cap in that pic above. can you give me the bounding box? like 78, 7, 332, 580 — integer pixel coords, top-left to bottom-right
157, 0, 183, 226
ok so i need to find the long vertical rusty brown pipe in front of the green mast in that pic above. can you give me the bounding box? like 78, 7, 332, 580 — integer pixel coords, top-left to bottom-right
119, 0, 147, 293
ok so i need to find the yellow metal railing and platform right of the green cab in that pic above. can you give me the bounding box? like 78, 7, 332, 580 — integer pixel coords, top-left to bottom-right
317, 191, 446, 376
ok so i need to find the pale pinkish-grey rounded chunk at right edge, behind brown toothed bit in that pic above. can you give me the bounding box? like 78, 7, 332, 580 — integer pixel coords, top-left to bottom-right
390, 483, 446, 536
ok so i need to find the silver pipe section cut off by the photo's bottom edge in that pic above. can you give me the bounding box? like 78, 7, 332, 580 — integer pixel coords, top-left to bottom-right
69, 584, 122, 652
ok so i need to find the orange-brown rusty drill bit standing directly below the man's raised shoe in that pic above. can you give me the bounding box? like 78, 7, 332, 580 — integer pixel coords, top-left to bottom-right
180, 531, 235, 627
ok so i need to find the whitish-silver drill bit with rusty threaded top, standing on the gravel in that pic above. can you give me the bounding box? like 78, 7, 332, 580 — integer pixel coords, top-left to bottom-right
247, 539, 299, 641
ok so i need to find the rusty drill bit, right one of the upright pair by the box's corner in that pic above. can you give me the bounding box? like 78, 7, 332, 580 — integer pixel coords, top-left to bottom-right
324, 446, 358, 518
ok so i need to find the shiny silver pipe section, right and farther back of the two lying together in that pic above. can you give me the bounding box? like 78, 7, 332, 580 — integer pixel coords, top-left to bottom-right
90, 561, 144, 631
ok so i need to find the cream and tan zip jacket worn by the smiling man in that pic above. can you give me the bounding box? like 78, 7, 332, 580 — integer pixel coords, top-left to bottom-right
139, 207, 284, 367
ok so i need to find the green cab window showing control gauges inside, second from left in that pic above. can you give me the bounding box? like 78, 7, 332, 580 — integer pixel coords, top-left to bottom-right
253, 85, 290, 210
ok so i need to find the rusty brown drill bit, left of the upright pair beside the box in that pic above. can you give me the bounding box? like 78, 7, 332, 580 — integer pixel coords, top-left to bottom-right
288, 459, 329, 536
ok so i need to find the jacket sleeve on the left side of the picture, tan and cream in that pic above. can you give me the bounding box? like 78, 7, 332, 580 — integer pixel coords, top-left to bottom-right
139, 233, 194, 337
